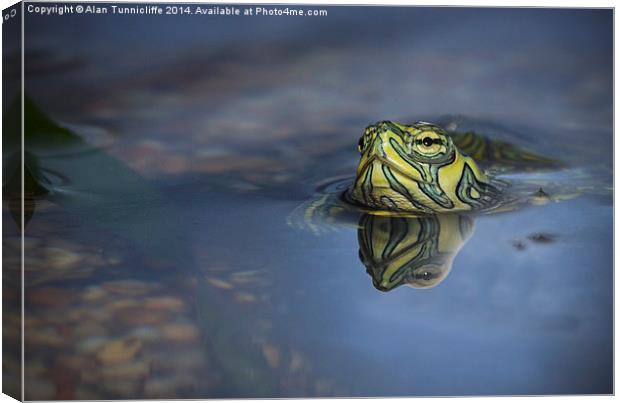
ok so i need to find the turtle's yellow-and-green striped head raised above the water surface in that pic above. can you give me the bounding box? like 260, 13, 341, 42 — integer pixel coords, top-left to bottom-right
348, 121, 500, 214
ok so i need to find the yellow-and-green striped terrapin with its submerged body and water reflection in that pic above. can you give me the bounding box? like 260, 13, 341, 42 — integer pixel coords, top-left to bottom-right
289, 121, 574, 291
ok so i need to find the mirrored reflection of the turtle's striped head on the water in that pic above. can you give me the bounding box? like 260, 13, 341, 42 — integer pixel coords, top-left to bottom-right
357, 214, 474, 291
